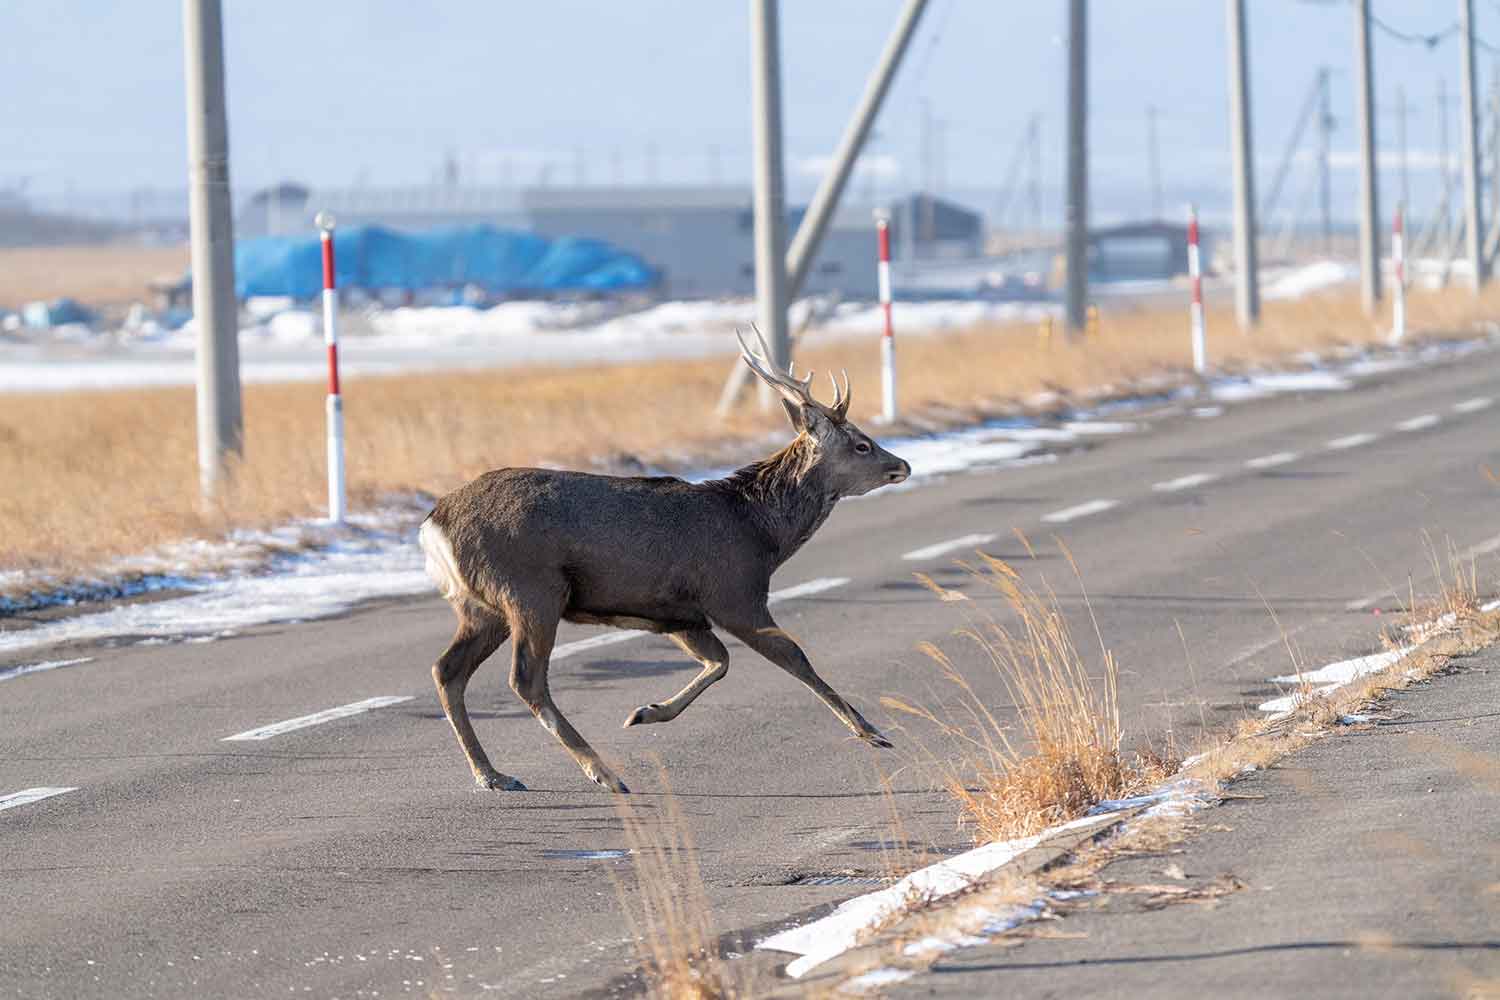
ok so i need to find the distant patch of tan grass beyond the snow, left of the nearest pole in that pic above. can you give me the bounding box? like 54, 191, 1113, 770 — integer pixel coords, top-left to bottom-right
0, 244, 188, 307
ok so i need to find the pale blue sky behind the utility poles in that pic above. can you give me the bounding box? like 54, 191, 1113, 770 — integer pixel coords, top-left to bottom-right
0, 0, 1500, 224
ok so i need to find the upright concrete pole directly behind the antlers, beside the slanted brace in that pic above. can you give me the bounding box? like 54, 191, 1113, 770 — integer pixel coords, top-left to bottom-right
750, 0, 792, 372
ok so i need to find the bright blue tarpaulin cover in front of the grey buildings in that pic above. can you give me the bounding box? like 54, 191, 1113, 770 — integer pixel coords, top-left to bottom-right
234, 225, 659, 298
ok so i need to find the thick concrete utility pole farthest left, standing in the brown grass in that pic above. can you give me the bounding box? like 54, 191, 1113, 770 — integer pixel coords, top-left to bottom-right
183, 0, 245, 499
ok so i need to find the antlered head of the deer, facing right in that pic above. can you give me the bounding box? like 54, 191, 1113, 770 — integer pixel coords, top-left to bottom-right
735, 325, 912, 496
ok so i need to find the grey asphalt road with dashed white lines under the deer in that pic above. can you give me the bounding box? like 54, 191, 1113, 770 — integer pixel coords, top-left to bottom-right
0, 352, 1500, 997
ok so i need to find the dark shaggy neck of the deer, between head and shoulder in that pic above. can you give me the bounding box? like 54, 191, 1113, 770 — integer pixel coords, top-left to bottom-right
720, 433, 839, 565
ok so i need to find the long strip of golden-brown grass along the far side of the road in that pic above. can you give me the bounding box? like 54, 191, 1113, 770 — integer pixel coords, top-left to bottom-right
0, 281, 1500, 573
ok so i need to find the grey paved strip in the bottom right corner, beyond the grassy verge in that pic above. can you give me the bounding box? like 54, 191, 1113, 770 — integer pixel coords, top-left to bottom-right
885, 646, 1500, 997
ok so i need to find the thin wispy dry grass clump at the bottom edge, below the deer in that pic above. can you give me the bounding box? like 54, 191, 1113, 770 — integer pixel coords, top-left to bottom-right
615, 772, 749, 1000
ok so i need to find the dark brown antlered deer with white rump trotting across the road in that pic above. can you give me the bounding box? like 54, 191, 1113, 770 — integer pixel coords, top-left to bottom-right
420, 331, 911, 792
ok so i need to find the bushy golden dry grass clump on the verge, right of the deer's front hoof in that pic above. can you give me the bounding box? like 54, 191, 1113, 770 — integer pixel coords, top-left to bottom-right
882, 553, 1169, 841
